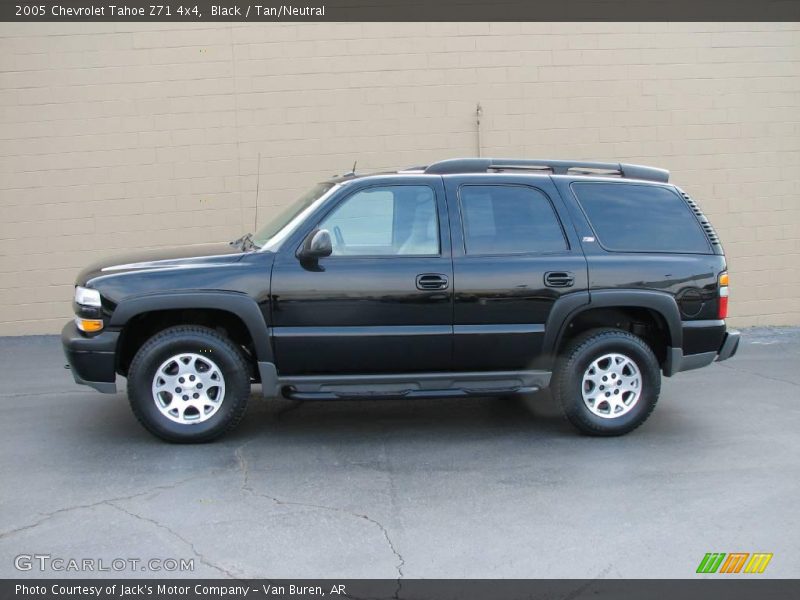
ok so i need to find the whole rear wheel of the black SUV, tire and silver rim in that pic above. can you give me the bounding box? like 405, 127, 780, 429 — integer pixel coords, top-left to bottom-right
552, 329, 661, 436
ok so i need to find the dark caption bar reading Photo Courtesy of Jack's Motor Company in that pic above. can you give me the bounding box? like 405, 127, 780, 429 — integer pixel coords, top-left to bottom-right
0, 575, 800, 600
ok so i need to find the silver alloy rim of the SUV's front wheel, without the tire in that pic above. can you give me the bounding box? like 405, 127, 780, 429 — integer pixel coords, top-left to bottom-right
153, 353, 225, 425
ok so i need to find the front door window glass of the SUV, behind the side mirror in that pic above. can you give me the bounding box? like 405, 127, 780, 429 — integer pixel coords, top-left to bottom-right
319, 185, 439, 256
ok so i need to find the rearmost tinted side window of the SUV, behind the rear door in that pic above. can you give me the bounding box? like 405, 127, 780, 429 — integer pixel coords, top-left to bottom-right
572, 183, 711, 254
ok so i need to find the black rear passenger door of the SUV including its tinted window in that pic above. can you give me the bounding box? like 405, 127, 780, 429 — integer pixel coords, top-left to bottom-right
444, 175, 587, 370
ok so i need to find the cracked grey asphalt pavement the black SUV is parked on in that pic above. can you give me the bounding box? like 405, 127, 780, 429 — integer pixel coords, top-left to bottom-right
0, 328, 800, 578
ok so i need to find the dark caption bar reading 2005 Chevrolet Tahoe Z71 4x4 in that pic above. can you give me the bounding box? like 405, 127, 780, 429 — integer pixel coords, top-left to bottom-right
0, 0, 800, 23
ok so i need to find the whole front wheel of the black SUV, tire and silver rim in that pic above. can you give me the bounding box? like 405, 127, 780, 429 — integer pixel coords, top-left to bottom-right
128, 325, 250, 443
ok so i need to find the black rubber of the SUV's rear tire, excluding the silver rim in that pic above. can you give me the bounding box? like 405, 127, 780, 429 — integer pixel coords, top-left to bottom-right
558, 331, 661, 435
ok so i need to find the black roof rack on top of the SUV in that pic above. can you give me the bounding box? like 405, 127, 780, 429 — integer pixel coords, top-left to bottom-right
425, 158, 669, 183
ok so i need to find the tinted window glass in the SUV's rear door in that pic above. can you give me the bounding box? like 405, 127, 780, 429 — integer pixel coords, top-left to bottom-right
459, 185, 567, 254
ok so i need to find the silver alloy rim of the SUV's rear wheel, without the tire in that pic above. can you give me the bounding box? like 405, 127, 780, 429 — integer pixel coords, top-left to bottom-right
581, 354, 642, 419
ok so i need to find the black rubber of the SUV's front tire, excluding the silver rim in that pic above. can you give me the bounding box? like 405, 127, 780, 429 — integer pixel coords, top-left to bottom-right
128, 328, 250, 442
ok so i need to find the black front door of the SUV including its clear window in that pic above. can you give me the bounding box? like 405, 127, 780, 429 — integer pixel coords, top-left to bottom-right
271, 176, 453, 375
